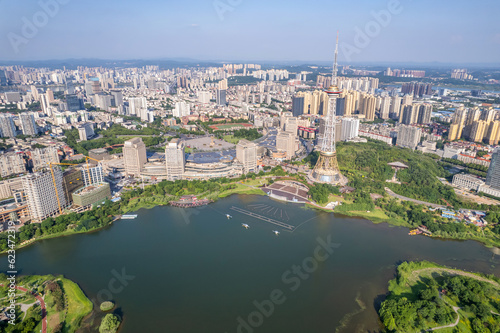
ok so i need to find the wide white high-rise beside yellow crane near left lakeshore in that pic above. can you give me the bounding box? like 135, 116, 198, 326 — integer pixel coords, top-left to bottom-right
23, 167, 67, 222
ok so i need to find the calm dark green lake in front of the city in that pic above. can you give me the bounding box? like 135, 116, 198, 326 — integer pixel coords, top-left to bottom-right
6, 196, 500, 333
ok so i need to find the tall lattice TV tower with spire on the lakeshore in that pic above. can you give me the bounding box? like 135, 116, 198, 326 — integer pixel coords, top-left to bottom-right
310, 32, 347, 185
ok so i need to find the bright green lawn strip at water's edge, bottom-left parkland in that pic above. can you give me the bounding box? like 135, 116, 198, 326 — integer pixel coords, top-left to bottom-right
61, 278, 93, 332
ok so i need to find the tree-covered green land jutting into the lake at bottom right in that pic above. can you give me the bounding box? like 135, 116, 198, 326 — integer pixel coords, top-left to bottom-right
379, 261, 500, 333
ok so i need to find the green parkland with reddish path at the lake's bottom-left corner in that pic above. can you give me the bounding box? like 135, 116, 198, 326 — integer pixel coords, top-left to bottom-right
0, 274, 93, 333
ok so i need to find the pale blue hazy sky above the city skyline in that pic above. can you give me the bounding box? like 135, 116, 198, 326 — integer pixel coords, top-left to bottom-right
0, 0, 500, 63
